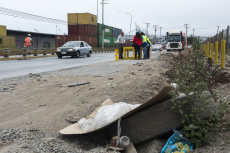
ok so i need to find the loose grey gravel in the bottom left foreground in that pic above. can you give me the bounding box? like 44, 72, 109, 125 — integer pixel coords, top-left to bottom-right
0, 128, 118, 153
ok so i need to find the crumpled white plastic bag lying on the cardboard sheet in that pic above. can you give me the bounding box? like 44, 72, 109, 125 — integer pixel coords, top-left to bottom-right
78, 102, 140, 132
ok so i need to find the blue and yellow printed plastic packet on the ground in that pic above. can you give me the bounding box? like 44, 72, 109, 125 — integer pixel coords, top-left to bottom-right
161, 129, 193, 153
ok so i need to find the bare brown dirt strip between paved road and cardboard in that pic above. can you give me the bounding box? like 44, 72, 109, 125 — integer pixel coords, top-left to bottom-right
0, 55, 165, 133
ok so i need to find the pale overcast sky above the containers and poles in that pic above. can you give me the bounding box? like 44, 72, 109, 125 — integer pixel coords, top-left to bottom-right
0, 0, 230, 36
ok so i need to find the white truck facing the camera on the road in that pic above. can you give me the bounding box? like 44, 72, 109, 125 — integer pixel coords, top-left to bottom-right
165, 30, 184, 51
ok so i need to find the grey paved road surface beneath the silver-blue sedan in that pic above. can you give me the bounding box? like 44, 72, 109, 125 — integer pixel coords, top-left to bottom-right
0, 52, 165, 79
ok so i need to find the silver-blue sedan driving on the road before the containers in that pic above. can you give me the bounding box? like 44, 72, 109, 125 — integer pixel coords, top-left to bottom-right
56, 41, 92, 58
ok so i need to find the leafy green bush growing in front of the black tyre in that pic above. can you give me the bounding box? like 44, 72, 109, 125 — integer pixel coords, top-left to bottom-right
170, 38, 227, 147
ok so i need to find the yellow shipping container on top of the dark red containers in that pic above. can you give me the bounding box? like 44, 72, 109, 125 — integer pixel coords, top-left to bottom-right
67, 13, 97, 26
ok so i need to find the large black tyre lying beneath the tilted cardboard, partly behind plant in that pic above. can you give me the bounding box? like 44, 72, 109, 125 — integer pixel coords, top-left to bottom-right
108, 92, 215, 145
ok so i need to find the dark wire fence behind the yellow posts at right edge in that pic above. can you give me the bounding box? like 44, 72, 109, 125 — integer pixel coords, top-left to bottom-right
202, 26, 230, 55
